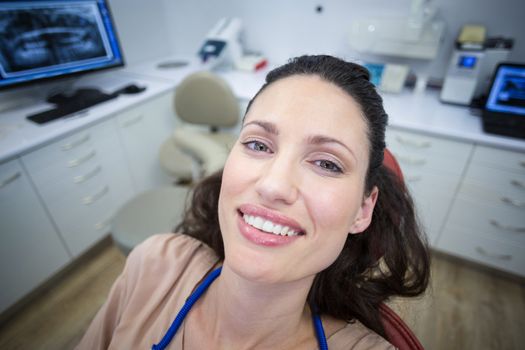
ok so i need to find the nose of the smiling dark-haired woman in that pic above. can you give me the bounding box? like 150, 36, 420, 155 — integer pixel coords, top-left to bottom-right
255, 155, 299, 205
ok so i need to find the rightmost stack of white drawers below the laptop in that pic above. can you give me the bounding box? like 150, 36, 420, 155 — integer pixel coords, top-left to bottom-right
437, 146, 525, 275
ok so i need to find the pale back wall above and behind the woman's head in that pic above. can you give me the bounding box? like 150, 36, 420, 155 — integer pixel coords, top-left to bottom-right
158, 0, 525, 77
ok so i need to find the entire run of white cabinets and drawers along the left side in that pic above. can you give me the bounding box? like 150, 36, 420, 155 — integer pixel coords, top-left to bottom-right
0, 89, 176, 312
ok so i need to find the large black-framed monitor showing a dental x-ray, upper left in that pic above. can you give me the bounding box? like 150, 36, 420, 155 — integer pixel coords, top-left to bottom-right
0, 0, 124, 88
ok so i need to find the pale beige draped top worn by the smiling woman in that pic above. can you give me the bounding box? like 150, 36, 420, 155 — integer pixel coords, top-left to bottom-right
77, 234, 393, 350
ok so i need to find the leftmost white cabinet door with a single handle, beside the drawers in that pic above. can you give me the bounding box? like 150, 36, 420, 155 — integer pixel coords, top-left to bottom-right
0, 160, 70, 312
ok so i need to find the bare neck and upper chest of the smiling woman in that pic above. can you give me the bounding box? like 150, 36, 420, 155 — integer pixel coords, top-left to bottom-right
193, 265, 315, 349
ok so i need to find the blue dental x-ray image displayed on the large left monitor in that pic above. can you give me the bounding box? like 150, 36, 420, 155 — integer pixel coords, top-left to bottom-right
0, 2, 112, 78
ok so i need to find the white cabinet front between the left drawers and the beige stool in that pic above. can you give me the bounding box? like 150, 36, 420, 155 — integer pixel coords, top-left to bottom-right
116, 93, 176, 192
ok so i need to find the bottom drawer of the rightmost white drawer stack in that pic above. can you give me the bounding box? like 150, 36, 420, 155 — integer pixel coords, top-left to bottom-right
437, 226, 525, 276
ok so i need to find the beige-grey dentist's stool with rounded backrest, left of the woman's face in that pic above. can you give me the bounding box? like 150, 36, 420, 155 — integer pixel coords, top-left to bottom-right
111, 71, 240, 255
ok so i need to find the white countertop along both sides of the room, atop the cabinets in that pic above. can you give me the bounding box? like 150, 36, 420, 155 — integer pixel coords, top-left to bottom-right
0, 56, 525, 162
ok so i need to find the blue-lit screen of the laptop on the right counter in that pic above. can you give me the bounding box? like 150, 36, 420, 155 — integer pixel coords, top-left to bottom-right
485, 65, 525, 115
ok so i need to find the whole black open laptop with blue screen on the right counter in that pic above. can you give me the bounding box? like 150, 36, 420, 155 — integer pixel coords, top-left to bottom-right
482, 63, 525, 138
